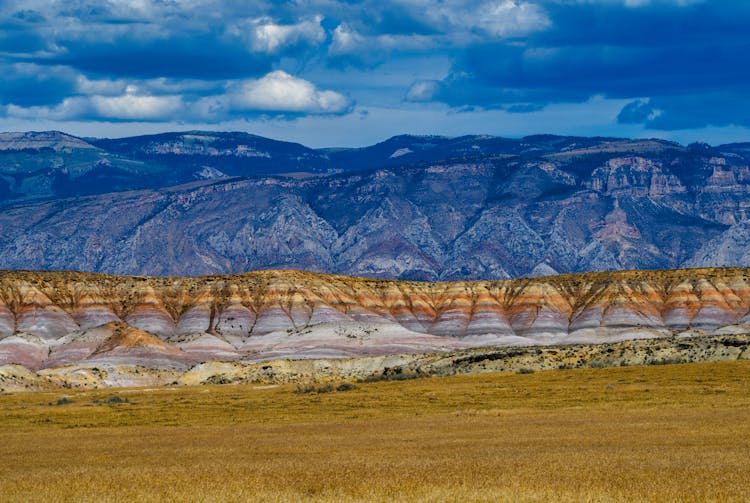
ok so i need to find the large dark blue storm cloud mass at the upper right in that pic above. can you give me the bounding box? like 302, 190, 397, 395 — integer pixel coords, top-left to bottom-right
421, 1, 750, 129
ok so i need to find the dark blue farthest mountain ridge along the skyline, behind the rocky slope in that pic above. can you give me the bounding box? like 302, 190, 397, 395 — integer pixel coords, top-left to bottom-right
0, 131, 704, 204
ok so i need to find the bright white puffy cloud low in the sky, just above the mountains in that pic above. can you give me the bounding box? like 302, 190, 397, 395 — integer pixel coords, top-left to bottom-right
227, 70, 351, 114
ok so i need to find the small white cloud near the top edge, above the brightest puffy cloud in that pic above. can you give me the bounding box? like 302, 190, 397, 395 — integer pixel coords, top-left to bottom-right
227, 15, 326, 54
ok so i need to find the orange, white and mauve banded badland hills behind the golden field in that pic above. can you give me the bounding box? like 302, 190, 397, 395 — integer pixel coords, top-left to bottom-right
0, 269, 750, 370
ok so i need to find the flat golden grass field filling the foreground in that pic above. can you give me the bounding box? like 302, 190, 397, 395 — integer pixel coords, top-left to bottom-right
0, 361, 750, 501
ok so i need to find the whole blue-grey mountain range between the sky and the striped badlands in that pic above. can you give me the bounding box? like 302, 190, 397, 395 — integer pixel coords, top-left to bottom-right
0, 131, 750, 281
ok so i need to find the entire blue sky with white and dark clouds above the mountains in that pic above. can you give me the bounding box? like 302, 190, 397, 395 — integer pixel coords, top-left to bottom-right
0, 0, 750, 147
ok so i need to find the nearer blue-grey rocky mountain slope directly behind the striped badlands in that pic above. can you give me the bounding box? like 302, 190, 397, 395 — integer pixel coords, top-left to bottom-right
0, 157, 750, 280
